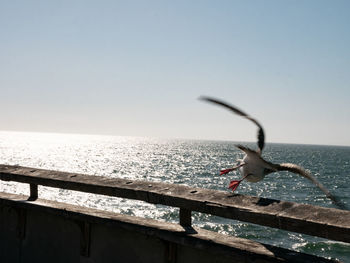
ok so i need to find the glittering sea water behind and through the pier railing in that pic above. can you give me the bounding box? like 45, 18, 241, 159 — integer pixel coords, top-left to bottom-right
0, 132, 350, 262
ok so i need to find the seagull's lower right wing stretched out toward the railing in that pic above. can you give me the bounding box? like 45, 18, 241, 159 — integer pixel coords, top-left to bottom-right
273, 163, 345, 209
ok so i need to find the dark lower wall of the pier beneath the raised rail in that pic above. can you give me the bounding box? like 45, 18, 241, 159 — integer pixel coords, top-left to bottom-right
0, 193, 335, 263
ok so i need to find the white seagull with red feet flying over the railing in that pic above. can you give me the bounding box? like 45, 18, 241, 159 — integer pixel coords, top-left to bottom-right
199, 96, 344, 208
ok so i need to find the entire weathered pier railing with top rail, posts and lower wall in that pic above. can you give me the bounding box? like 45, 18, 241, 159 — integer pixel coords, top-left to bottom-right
0, 165, 350, 263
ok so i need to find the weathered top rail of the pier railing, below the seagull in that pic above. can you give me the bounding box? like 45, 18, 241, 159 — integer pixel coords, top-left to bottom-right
0, 165, 350, 243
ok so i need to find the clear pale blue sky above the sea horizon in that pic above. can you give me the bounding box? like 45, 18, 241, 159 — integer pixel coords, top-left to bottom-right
0, 0, 350, 145
